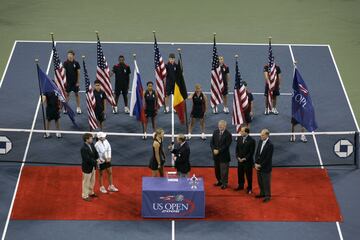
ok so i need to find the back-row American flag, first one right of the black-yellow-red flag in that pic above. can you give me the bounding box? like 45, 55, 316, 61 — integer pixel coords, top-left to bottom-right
210, 37, 224, 108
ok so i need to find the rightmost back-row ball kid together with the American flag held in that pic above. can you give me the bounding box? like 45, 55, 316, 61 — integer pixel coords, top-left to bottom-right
264, 37, 281, 115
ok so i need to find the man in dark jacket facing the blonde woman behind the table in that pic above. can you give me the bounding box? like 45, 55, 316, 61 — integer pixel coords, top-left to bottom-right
171, 134, 191, 177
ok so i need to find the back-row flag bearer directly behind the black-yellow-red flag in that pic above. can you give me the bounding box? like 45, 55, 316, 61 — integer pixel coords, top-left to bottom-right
164, 53, 179, 113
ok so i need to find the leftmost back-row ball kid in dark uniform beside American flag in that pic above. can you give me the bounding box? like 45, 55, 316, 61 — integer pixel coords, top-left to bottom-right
63, 50, 81, 114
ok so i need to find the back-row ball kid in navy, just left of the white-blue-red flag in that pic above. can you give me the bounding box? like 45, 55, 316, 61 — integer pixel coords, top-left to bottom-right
110, 55, 131, 114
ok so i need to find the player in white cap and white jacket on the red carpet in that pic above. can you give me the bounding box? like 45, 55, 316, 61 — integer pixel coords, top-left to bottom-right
95, 132, 119, 193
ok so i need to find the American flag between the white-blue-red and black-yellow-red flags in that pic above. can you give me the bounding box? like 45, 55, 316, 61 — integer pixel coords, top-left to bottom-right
154, 36, 166, 107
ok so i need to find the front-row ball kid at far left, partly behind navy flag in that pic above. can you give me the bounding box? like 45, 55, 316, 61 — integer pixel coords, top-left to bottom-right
42, 92, 61, 138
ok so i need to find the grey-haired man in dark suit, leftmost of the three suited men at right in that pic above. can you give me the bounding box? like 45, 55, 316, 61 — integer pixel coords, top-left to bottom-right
210, 120, 232, 189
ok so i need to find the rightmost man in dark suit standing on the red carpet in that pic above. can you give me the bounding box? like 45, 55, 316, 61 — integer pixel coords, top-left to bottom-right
255, 129, 274, 202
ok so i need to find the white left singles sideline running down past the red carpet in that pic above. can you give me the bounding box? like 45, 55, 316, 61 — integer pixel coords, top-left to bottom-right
1, 47, 53, 240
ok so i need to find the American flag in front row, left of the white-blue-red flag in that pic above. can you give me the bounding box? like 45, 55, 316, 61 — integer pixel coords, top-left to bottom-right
83, 60, 99, 130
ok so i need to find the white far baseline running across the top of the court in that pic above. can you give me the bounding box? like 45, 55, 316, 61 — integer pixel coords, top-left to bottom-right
16, 40, 328, 47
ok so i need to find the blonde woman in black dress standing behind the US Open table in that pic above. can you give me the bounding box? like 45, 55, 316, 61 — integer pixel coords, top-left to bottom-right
149, 128, 165, 177
